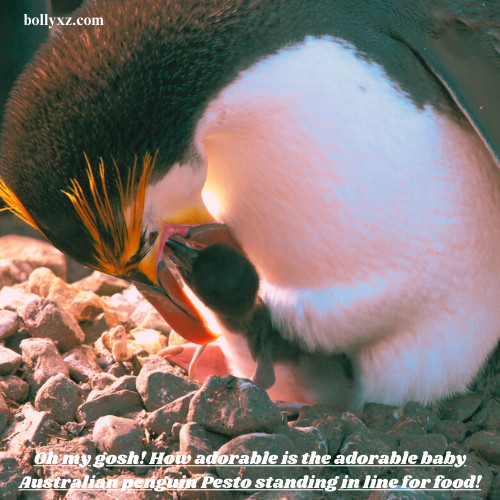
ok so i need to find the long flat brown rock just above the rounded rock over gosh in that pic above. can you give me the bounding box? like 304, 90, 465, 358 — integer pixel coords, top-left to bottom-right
77, 390, 143, 423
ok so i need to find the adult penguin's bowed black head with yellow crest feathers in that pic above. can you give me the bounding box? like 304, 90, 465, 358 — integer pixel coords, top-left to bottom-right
0, 2, 236, 343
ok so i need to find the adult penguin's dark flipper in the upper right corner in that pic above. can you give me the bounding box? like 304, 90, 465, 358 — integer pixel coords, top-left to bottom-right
410, 9, 500, 162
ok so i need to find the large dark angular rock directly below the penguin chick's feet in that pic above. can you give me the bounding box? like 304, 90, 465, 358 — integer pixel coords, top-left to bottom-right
188, 375, 284, 436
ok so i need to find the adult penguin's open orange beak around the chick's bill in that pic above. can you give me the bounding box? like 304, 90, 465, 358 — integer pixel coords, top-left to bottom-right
134, 224, 220, 345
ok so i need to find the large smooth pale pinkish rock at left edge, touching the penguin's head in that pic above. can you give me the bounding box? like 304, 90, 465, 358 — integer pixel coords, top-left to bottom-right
0, 235, 66, 283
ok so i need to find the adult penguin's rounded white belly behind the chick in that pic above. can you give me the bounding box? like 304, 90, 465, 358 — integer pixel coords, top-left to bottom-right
192, 38, 500, 406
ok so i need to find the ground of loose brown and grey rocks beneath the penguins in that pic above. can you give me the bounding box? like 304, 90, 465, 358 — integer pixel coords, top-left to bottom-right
0, 215, 500, 500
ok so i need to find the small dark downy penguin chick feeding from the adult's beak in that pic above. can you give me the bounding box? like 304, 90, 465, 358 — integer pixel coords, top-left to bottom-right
166, 235, 354, 408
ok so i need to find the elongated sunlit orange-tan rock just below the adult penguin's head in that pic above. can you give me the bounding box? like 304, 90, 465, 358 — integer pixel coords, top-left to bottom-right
28, 268, 106, 321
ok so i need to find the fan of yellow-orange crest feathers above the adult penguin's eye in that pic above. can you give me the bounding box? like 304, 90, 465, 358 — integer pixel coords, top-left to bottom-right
63, 153, 157, 276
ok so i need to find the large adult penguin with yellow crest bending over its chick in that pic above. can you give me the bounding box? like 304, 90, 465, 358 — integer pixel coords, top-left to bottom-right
0, 0, 500, 405
